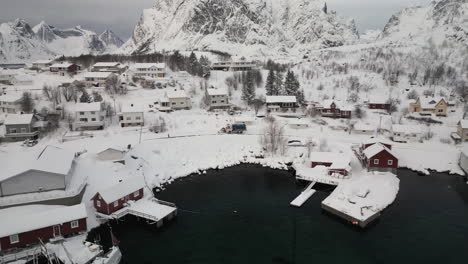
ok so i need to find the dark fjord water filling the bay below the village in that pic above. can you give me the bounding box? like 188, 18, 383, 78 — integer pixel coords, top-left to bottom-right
89, 165, 468, 264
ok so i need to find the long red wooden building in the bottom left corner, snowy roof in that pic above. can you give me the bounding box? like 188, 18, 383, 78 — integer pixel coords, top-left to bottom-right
0, 204, 88, 251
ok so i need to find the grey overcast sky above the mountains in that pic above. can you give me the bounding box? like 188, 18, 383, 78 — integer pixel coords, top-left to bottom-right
0, 0, 430, 40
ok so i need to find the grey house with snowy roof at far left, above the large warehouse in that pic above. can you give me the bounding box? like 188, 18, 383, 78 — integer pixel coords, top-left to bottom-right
5, 114, 39, 141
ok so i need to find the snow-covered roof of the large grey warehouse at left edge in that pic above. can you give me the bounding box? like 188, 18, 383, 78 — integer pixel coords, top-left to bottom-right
0, 146, 75, 181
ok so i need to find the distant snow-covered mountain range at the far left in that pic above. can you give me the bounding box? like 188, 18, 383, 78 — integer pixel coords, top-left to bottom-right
0, 19, 123, 61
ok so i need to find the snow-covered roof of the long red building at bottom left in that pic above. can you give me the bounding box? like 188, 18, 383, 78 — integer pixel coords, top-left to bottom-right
0, 204, 88, 237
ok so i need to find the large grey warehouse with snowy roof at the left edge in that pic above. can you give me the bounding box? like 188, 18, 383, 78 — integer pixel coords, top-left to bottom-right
0, 146, 75, 197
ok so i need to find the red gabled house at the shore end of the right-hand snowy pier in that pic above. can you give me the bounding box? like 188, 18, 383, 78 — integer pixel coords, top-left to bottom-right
363, 143, 398, 171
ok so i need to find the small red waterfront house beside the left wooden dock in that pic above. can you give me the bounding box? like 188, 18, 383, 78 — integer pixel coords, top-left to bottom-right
91, 180, 144, 215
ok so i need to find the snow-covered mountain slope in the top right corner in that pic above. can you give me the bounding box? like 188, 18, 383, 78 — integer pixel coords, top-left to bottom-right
379, 0, 468, 45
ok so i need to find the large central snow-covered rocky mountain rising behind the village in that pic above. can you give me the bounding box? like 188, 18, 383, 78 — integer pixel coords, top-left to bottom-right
119, 0, 359, 56
